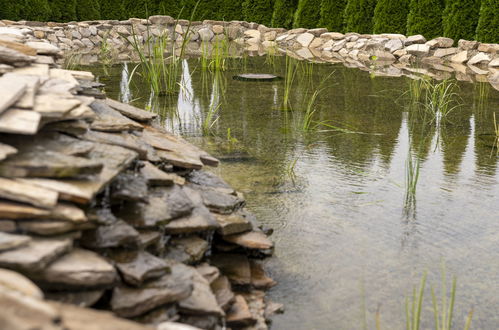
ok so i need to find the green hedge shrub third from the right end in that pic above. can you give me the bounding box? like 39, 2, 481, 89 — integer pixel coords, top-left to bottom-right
407, 0, 446, 40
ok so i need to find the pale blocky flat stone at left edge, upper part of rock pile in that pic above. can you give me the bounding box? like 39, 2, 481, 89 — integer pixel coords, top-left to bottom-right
0, 109, 42, 135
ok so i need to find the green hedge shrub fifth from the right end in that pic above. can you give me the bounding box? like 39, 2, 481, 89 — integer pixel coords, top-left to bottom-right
344, 0, 376, 33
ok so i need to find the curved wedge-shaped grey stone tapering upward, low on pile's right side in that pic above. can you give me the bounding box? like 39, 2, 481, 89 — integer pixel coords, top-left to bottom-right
176, 264, 225, 316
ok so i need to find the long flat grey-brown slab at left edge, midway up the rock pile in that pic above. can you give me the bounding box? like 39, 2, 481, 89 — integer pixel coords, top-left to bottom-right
0, 150, 103, 178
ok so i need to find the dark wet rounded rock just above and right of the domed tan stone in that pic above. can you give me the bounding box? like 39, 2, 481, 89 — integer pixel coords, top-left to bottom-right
81, 220, 140, 249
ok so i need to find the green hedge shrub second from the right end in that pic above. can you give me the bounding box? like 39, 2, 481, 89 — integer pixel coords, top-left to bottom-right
443, 0, 482, 41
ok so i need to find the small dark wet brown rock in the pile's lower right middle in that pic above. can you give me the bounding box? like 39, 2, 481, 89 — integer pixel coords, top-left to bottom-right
166, 236, 209, 264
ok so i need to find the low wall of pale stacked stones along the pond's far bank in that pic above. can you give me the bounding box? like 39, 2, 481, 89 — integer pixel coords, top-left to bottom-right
0, 16, 499, 89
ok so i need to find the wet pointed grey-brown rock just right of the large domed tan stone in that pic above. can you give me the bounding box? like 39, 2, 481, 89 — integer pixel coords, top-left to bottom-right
112, 251, 170, 286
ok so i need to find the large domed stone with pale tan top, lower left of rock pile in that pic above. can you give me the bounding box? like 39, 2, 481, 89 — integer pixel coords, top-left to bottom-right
34, 249, 117, 289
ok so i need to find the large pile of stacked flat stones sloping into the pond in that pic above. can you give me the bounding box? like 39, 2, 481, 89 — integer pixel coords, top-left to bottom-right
0, 29, 280, 329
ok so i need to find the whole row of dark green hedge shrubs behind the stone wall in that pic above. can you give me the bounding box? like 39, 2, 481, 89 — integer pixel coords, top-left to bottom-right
0, 0, 499, 43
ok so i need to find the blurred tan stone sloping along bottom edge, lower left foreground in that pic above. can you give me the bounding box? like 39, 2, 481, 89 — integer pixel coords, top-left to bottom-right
50, 302, 151, 330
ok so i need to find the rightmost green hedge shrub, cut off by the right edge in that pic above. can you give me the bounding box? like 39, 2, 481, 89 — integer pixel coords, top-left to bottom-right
476, 0, 499, 43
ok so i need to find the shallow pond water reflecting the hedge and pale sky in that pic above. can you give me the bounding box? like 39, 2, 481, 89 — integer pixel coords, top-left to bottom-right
85, 56, 499, 329
